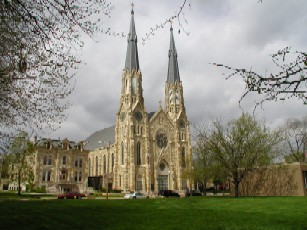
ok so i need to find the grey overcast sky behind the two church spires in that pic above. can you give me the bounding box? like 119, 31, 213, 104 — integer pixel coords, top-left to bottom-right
45, 0, 307, 141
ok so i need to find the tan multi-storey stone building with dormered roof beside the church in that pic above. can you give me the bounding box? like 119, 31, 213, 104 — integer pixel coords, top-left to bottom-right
33, 139, 89, 193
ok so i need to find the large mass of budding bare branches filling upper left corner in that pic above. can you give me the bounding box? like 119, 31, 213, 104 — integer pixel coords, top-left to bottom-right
0, 0, 112, 152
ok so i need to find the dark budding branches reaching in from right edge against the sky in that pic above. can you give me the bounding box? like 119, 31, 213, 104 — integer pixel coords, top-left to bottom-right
213, 47, 307, 107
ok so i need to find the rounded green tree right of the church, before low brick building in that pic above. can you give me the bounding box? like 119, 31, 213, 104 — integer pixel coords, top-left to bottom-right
203, 114, 280, 196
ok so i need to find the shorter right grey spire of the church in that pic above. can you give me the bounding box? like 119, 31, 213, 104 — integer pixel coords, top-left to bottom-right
167, 26, 180, 83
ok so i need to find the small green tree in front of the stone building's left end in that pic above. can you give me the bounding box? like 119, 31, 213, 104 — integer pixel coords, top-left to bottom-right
5, 131, 35, 195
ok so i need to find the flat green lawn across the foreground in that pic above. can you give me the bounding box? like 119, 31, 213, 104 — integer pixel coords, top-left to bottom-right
0, 196, 307, 229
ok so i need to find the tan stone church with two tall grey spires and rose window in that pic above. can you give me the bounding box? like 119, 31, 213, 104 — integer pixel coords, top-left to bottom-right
88, 9, 191, 192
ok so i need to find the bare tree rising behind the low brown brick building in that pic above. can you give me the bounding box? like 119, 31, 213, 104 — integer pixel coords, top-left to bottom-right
285, 117, 307, 163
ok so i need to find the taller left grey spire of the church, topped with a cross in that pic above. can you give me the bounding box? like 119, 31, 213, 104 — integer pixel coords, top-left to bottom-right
125, 3, 140, 71
